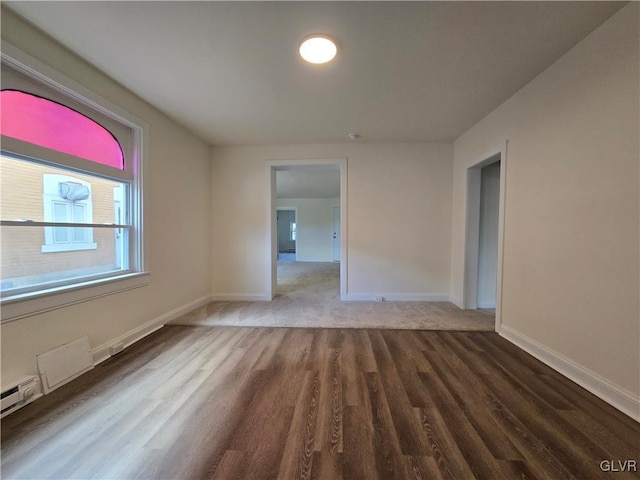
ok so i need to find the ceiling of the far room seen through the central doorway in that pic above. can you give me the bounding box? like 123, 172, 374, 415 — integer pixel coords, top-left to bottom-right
276, 165, 340, 198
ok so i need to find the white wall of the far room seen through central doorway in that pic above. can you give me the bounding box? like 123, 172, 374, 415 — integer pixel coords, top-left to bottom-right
276, 198, 340, 262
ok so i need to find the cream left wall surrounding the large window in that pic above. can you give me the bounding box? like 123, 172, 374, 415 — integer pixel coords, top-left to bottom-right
1, 9, 211, 385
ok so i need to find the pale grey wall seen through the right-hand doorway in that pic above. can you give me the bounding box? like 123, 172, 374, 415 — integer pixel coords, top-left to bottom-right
477, 162, 500, 308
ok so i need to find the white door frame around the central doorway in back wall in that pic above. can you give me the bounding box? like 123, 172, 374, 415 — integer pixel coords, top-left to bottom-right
265, 158, 347, 301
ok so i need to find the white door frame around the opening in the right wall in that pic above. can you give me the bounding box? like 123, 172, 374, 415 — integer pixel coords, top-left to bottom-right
463, 141, 507, 331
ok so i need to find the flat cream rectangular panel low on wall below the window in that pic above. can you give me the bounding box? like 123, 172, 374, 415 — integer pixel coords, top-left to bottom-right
36, 337, 93, 393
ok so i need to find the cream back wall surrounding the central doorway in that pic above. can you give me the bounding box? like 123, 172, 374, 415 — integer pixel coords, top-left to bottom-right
211, 143, 452, 299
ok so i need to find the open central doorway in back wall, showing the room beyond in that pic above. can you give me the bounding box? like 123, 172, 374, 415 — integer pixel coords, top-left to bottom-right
268, 159, 346, 300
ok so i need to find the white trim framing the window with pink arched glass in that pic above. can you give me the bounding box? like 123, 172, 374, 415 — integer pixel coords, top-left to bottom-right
0, 41, 151, 323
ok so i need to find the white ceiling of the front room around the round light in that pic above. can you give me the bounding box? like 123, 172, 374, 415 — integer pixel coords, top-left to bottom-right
3, 1, 625, 145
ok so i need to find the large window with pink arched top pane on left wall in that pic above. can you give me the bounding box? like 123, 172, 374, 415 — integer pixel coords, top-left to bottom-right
0, 54, 148, 321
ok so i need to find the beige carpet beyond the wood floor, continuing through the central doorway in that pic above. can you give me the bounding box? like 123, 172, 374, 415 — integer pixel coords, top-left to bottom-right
171, 261, 495, 331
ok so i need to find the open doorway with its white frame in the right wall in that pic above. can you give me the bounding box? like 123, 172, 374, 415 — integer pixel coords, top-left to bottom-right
464, 143, 507, 331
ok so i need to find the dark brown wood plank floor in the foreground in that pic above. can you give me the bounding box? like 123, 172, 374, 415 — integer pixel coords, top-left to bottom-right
1, 326, 640, 480
